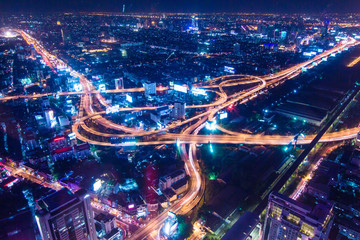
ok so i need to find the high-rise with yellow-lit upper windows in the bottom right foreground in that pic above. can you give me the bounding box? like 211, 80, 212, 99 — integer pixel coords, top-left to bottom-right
263, 193, 333, 240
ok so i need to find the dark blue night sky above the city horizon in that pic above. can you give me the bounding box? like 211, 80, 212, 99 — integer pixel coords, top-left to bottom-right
0, 0, 360, 13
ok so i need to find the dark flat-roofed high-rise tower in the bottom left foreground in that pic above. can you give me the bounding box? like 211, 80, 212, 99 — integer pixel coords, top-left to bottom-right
35, 188, 97, 240
